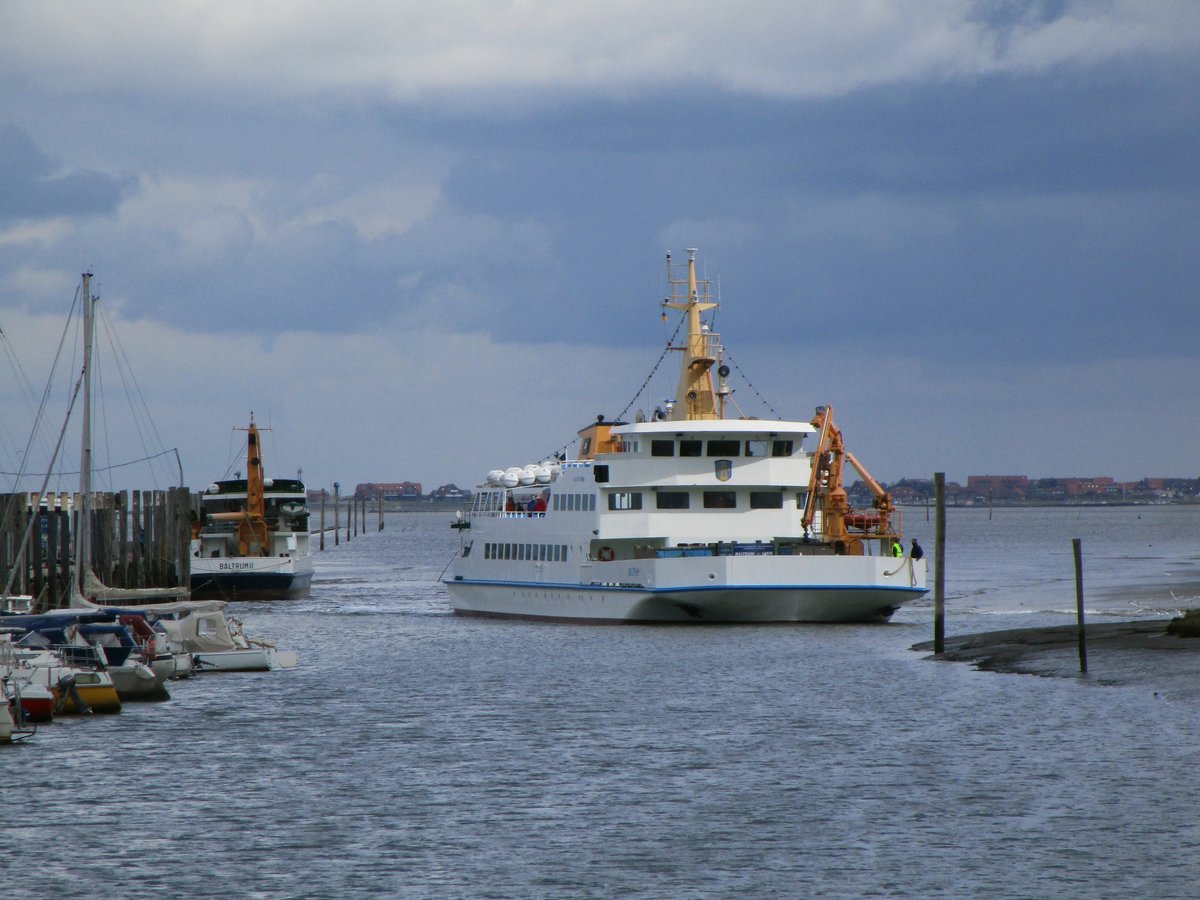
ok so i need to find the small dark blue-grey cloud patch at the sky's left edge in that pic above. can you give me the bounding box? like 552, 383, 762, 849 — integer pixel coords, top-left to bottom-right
0, 122, 133, 221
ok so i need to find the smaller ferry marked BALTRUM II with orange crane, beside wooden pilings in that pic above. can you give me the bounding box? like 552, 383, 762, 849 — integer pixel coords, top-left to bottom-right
191, 414, 312, 600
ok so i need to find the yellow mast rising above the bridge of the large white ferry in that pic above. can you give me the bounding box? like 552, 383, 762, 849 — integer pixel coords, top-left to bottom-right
662, 247, 725, 420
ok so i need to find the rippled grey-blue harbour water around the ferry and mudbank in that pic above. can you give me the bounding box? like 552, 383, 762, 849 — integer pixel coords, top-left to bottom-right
9, 506, 1200, 898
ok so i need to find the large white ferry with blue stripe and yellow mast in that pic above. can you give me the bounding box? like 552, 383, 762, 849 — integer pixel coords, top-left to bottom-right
445, 250, 926, 623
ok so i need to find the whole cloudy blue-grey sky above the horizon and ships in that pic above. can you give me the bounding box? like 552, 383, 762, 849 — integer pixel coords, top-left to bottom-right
0, 0, 1200, 490
